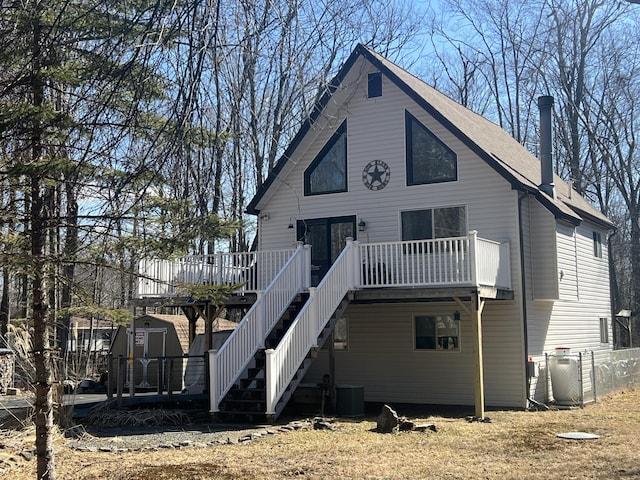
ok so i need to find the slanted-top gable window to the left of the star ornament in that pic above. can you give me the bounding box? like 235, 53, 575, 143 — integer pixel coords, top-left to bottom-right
304, 121, 347, 195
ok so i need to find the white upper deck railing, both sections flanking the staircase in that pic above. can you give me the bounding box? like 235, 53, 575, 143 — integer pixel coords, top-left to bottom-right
138, 231, 511, 297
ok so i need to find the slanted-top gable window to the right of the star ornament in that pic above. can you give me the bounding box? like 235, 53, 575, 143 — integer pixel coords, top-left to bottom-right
405, 112, 458, 185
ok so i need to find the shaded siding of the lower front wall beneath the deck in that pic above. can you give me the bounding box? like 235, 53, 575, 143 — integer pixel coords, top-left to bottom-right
303, 302, 525, 408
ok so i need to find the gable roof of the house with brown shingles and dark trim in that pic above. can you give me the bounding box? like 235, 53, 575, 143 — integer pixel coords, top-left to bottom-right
247, 45, 613, 228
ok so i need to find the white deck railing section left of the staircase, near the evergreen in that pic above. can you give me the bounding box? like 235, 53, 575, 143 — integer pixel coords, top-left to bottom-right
137, 249, 294, 298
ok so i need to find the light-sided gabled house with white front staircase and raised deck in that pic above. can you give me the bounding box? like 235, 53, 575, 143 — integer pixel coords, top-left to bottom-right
142, 45, 613, 417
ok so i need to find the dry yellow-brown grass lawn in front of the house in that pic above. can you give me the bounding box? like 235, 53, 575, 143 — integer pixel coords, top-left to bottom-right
7, 389, 640, 480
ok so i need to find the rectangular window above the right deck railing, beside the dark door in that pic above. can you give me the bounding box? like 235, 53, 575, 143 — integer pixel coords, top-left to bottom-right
400, 207, 467, 240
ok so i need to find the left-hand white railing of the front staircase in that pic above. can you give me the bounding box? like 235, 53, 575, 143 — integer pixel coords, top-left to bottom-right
209, 245, 311, 412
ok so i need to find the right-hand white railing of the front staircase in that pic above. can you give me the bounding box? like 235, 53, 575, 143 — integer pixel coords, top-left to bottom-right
265, 239, 360, 415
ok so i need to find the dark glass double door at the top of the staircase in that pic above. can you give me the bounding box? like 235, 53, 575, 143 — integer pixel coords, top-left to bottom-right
297, 216, 356, 287
